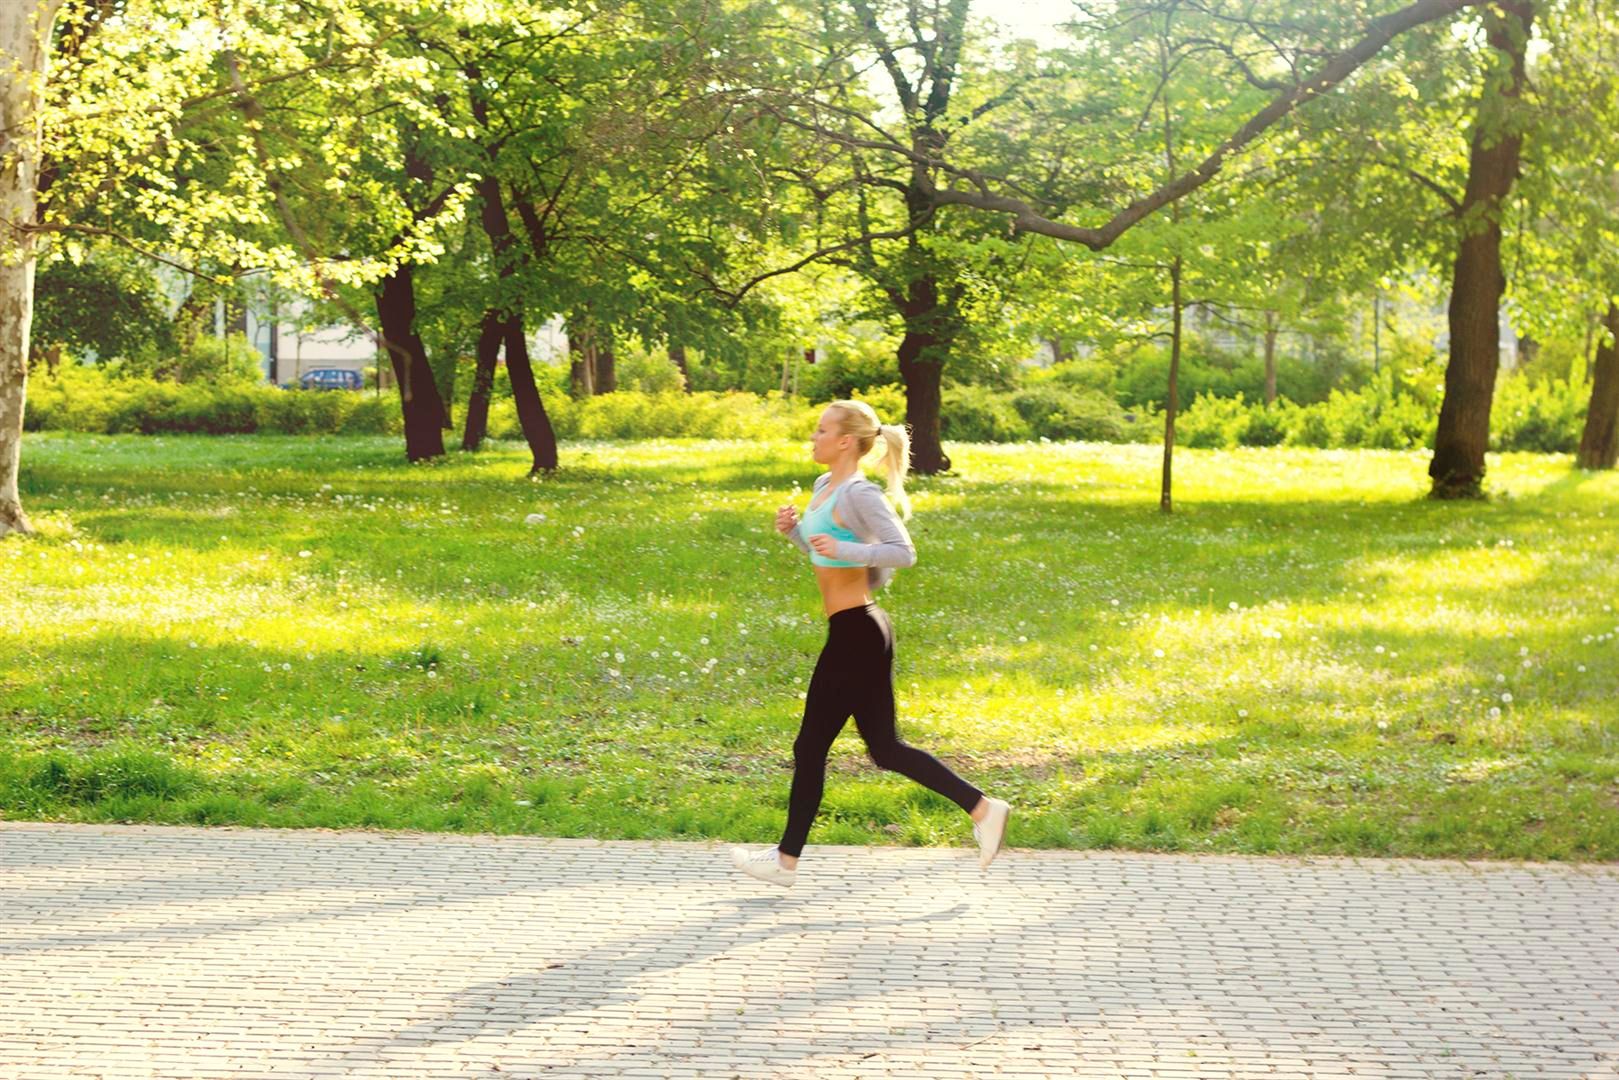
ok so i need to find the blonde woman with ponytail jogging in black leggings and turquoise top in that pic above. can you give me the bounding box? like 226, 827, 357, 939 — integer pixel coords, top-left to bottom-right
730, 402, 1012, 886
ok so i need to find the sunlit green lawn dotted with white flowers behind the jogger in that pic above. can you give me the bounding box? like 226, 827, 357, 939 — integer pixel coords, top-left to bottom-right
9, 436, 1619, 860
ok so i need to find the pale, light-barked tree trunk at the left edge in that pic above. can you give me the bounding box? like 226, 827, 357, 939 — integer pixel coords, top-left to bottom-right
0, 0, 62, 536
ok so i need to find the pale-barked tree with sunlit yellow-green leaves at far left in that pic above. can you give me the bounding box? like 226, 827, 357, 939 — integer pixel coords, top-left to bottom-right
0, 0, 468, 531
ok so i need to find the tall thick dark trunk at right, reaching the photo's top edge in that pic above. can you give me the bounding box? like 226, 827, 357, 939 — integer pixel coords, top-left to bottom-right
1428, 0, 1535, 499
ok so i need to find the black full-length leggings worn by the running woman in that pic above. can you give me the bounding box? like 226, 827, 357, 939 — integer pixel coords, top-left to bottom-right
779, 604, 983, 857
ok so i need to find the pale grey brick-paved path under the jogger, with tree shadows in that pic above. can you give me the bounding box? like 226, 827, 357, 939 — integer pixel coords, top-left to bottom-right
0, 824, 1619, 1080
